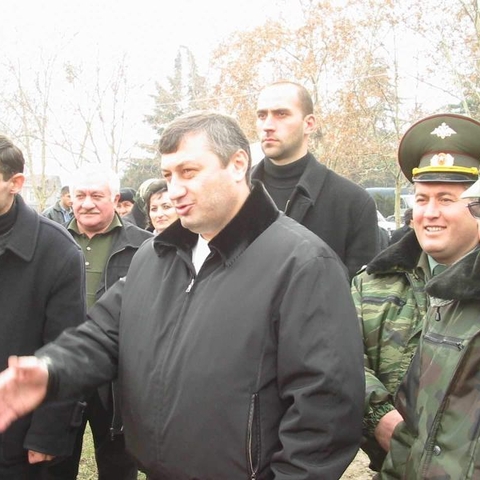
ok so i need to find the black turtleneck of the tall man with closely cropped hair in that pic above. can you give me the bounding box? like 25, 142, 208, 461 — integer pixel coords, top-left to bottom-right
263, 155, 308, 211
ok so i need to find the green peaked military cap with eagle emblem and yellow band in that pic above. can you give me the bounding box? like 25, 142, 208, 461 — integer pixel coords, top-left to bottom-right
398, 113, 480, 182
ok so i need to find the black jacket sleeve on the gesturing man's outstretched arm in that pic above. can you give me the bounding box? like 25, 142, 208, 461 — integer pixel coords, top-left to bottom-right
35, 279, 125, 401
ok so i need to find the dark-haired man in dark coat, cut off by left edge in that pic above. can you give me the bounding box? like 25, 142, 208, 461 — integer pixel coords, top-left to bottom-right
0, 135, 86, 480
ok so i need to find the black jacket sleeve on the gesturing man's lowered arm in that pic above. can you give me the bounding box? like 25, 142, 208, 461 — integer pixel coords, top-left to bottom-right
271, 253, 365, 480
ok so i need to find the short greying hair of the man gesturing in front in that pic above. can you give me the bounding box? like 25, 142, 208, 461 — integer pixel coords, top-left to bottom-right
158, 111, 252, 182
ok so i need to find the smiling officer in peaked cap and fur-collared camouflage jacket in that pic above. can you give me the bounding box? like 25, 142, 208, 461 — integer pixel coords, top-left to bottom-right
352, 114, 480, 472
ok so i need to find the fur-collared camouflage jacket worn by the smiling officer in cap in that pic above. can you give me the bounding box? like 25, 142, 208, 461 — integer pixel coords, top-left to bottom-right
352, 231, 429, 470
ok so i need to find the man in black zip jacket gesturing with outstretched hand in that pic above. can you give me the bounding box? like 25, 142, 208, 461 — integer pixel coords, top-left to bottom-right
0, 112, 364, 480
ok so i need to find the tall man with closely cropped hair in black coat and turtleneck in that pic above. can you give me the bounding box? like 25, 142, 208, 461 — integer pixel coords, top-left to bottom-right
252, 82, 380, 278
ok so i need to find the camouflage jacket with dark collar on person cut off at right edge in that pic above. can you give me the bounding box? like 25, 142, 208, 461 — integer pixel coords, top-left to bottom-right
381, 249, 480, 480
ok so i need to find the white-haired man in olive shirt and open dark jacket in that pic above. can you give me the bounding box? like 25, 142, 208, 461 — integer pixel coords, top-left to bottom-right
46, 165, 153, 480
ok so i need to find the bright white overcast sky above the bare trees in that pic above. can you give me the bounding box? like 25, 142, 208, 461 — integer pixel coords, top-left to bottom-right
0, 0, 299, 176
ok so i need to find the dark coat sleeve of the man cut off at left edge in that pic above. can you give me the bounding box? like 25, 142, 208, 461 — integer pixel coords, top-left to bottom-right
23, 242, 86, 456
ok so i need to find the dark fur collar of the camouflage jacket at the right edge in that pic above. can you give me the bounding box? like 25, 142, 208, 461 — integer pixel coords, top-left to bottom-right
426, 248, 480, 302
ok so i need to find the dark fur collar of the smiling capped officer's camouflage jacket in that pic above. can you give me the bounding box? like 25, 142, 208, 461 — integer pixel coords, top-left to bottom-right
367, 230, 422, 274
